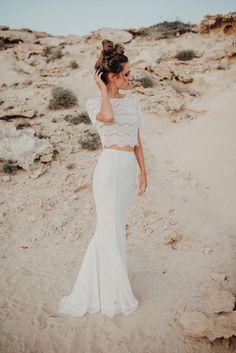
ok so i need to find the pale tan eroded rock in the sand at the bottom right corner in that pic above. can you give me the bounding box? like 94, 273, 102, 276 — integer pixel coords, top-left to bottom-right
173, 283, 236, 341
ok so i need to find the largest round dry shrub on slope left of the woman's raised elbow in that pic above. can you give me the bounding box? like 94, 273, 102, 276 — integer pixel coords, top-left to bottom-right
48, 86, 78, 110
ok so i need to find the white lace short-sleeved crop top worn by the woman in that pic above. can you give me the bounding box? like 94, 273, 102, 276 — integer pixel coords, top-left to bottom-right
86, 91, 145, 147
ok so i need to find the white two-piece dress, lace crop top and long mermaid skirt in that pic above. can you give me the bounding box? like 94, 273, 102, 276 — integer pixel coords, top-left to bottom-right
59, 91, 144, 317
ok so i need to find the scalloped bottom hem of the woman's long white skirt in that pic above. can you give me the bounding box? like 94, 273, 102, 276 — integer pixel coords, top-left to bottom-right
61, 300, 139, 318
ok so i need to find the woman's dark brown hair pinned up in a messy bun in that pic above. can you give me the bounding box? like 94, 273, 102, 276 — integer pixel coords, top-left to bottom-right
94, 39, 129, 84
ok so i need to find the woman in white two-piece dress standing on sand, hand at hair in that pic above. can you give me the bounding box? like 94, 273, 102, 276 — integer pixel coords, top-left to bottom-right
59, 39, 147, 317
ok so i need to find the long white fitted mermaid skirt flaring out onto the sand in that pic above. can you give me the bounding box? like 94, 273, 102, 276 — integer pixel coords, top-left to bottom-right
59, 148, 139, 317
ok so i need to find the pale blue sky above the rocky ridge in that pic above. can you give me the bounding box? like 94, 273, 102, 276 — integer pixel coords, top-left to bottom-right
0, 0, 236, 35
